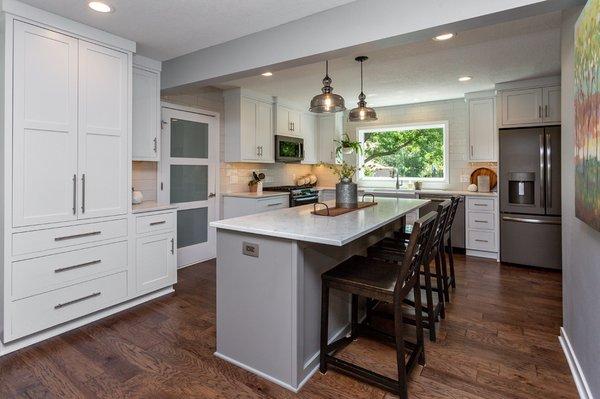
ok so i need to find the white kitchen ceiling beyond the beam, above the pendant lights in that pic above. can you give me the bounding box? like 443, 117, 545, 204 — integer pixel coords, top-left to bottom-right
219, 12, 561, 108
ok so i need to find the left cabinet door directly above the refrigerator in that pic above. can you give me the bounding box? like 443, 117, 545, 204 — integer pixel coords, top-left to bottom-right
502, 89, 543, 125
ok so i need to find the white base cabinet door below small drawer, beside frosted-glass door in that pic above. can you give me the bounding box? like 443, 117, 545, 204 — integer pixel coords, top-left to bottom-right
135, 234, 177, 294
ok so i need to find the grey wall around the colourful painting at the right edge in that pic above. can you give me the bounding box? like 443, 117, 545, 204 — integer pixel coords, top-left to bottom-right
561, 8, 600, 397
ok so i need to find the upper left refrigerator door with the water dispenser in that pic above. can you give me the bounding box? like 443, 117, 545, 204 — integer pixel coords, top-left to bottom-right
499, 128, 545, 215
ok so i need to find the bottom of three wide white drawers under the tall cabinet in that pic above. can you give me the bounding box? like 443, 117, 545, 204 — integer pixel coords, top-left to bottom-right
5, 272, 127, 341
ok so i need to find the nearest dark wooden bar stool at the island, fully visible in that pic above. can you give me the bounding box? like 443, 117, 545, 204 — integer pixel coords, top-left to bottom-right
319, 212, 437, 399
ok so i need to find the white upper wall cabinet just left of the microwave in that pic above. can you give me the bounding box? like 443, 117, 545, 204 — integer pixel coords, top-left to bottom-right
224, 89, 275, 163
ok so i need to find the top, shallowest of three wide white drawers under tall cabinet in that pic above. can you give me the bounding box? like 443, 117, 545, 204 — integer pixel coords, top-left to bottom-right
12, 219, 127, 255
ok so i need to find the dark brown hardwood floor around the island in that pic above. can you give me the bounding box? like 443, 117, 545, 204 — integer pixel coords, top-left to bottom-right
0, 255, 577, 399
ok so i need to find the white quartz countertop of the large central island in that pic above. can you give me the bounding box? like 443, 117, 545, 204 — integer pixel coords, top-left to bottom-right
210, 198, 429, 246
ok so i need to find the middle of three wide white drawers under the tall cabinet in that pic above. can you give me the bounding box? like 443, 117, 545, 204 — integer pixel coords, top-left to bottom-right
12, 241, 127, 299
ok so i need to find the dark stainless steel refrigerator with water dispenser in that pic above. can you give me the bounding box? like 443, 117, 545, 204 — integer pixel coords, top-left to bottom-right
499, 126, 562, 269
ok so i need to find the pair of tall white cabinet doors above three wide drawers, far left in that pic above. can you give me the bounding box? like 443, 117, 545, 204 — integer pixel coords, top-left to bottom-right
12, 21, 129, 226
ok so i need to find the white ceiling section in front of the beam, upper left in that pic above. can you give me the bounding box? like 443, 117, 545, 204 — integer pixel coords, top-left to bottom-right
21, 0, 353, 61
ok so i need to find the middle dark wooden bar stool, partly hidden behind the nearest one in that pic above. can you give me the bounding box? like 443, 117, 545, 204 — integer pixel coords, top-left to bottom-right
368, 200, 452, 341
